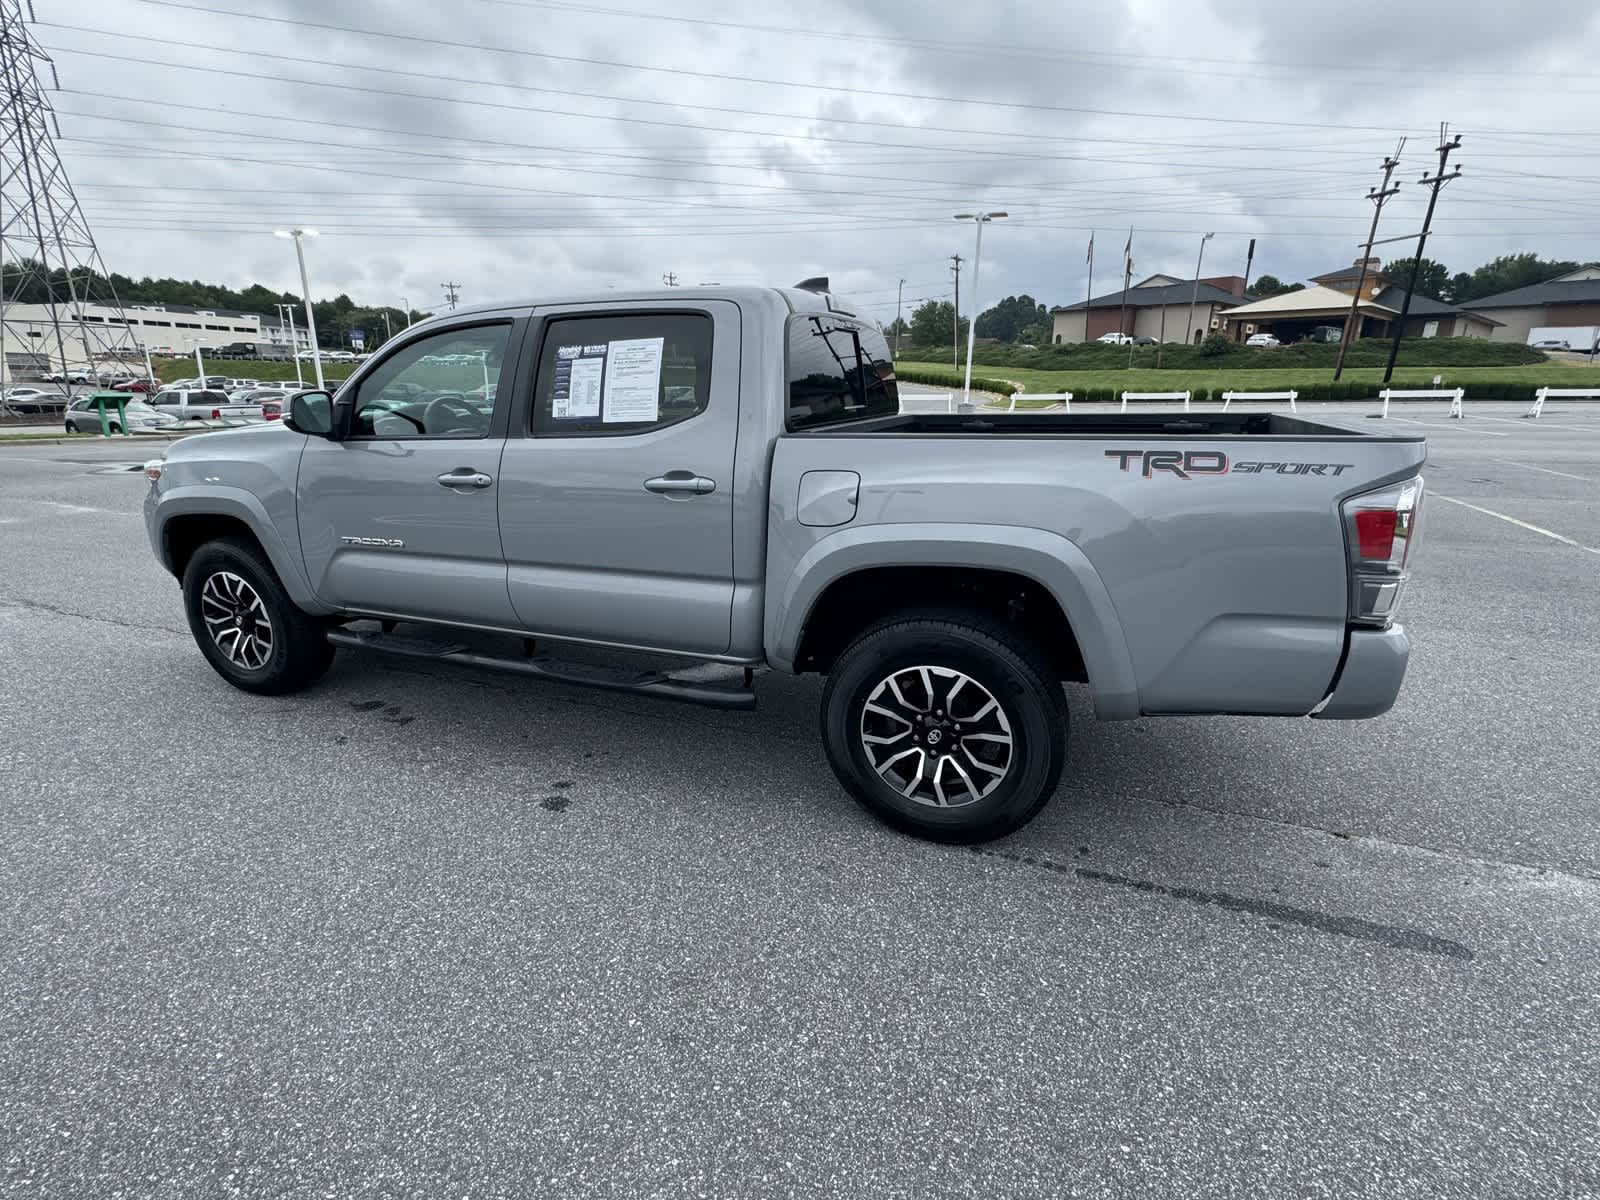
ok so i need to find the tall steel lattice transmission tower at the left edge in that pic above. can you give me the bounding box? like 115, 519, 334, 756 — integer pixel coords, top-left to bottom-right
0, 0, 142, 379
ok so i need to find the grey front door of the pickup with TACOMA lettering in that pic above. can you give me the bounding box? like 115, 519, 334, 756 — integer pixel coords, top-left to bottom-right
298, 317, 525, 627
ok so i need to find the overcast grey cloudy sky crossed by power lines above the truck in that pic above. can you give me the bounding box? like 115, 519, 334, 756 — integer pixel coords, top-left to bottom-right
34, 0, 1600, 320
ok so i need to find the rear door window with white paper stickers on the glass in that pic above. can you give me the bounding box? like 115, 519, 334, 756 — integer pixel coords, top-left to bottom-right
533, 312, 712, 437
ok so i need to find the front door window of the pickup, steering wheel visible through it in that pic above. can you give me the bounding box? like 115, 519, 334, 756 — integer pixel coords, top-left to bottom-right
350, 323, 510, 437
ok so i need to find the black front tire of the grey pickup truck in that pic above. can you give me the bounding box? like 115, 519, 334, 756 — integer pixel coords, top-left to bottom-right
184, 538, 333, 696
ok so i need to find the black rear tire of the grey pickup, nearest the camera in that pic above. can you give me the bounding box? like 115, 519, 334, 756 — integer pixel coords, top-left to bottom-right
821, 610, 1067, 843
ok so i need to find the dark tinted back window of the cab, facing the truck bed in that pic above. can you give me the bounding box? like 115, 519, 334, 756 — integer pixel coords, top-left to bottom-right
789, 314, 899, 430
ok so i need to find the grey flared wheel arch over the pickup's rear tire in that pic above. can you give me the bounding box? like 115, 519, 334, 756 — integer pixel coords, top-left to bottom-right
766, 523, 1139, 720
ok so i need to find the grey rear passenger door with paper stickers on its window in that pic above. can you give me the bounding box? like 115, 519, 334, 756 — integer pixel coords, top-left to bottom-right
499, 301, 739, 654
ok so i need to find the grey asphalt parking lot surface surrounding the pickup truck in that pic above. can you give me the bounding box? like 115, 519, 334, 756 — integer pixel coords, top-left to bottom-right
0, 402, 1600, 1200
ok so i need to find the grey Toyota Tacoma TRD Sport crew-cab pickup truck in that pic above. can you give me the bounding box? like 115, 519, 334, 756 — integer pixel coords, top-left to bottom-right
146, 280, 1426, 842
